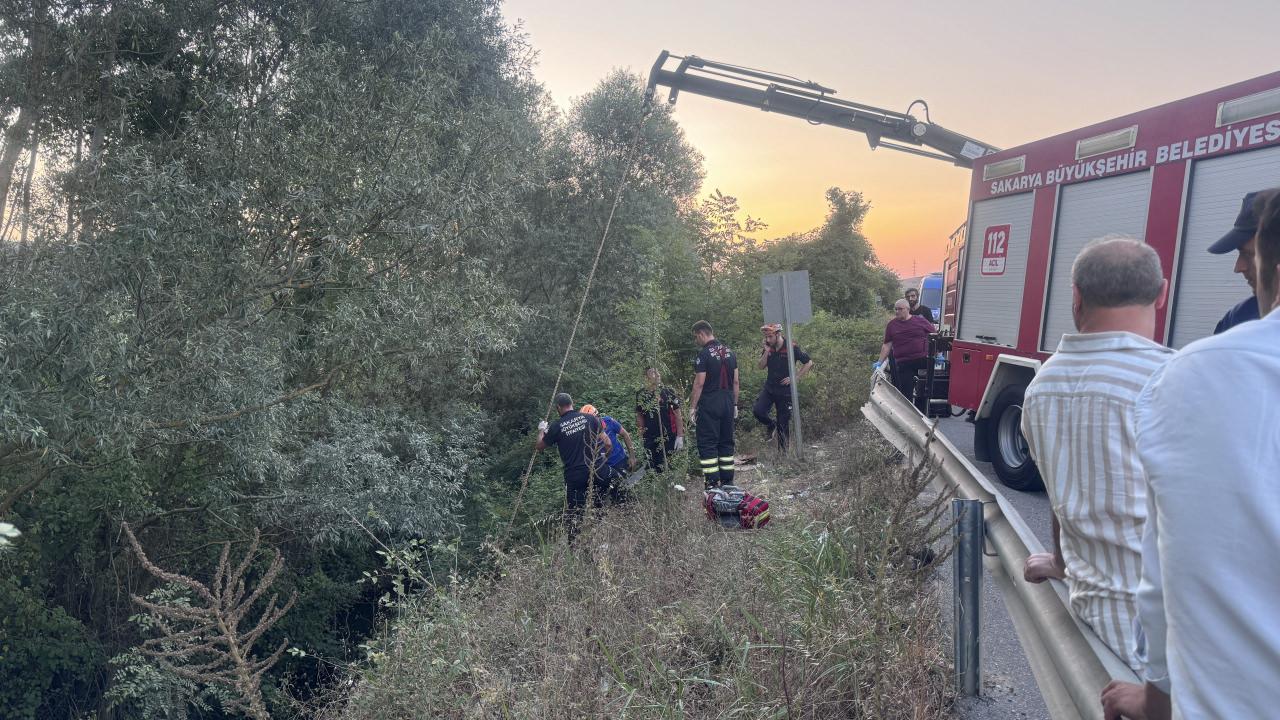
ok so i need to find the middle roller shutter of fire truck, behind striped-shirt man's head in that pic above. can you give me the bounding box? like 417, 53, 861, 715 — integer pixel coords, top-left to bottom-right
1041, 170, 1151, 352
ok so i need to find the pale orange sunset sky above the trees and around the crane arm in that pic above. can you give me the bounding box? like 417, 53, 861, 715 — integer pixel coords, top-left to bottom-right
506, 0, 1280, 275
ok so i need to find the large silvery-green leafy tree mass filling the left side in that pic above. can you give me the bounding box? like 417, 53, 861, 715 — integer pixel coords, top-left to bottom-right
0, 0, 549, 717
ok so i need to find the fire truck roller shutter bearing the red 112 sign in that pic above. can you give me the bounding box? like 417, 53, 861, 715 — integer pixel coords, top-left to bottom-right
959, 188, 1053, 347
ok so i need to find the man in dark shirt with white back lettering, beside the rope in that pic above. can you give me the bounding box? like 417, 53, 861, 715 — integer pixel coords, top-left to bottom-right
534, 392, 613, 541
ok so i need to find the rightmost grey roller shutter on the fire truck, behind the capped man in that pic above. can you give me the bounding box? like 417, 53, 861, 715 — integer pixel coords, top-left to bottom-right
1169, 141, 1280, 348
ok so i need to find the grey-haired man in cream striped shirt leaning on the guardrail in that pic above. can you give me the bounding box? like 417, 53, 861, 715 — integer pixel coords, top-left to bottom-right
1021, 237, 1172, 671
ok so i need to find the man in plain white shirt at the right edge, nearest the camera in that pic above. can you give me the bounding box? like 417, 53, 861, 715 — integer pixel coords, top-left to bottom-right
1134, 190, 1280, 719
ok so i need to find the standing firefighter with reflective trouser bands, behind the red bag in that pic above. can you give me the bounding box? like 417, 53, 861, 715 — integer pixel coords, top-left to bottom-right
689, 320, 737, 488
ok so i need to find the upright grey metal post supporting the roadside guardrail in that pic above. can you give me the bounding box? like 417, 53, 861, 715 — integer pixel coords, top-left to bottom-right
951, 498, 983, 697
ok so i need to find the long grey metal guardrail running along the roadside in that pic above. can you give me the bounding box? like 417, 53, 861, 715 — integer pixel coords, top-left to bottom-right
863, 372, 1139, 720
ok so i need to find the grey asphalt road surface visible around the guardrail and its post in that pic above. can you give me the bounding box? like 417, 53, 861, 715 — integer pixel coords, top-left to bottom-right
940, 418, 1052, 720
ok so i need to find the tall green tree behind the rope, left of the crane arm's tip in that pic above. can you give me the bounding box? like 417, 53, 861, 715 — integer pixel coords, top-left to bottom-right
489, 72, 703, 430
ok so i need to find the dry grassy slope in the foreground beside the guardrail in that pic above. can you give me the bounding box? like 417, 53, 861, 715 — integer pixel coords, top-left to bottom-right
321, 420, 950, 720
